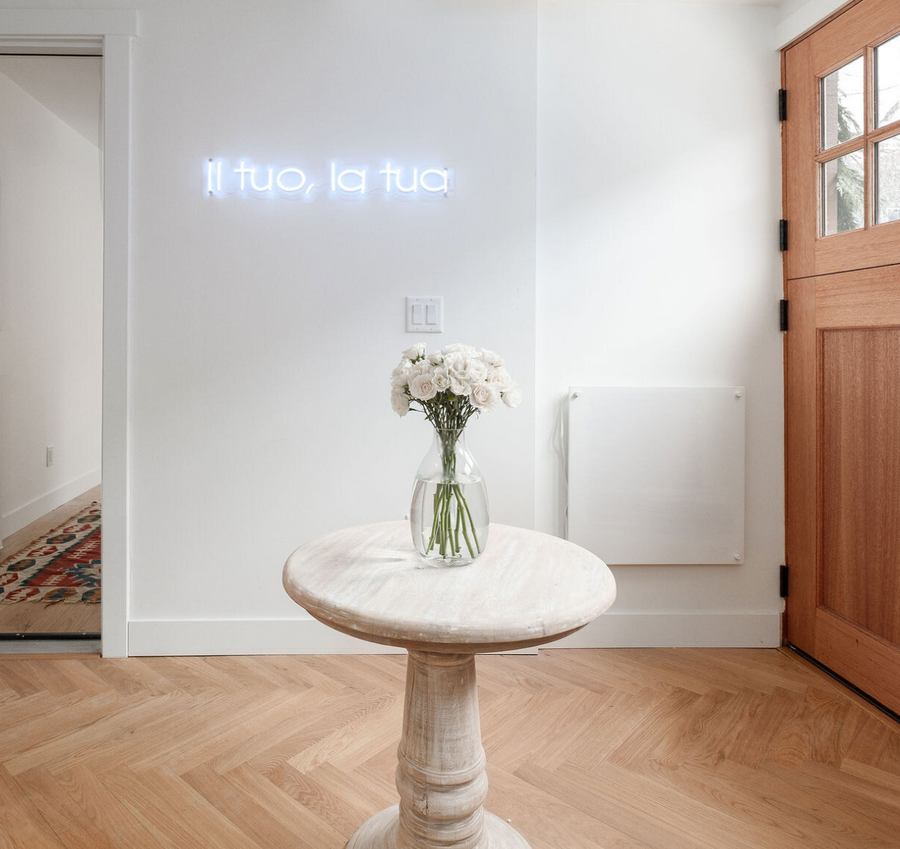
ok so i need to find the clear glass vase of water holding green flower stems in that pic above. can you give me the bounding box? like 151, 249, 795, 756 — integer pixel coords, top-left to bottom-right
409, 429, 490, 566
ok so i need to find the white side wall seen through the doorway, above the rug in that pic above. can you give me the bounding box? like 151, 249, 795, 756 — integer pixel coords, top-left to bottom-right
0, 68, 102, 536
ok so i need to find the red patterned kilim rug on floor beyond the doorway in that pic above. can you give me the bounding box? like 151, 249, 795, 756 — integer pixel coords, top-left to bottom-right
0, 501, 100, 604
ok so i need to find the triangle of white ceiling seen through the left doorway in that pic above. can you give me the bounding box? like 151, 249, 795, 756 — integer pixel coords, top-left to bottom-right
0, 56, 101, 148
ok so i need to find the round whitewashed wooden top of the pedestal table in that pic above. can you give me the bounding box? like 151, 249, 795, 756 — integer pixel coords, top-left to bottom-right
284, 522, 616, 654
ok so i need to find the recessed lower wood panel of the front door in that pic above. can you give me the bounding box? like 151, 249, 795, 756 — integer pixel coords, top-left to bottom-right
819, 328, 900, 643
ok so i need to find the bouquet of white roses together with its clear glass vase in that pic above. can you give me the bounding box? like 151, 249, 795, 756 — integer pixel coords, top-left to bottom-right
391, 342, 522, 564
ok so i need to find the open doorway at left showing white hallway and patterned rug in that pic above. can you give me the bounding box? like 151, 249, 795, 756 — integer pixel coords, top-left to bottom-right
0, 54, 103, 652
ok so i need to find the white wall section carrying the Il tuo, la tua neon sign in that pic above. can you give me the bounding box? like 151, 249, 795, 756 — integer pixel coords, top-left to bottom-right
123, 0, 536, 653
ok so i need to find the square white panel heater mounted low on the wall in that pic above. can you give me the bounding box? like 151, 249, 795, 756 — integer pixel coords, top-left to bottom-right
568, 386, 746, 565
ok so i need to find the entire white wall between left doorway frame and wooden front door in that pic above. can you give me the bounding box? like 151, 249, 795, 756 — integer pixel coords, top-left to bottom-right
0, 0, 800, 654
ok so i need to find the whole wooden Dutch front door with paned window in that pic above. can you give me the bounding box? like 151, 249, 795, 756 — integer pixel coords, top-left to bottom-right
783, 0, 900, 712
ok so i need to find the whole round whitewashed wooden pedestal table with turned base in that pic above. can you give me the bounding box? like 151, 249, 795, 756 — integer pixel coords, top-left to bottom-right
284, 522, 616, 849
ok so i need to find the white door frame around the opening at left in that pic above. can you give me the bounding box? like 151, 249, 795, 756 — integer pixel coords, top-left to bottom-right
0, 9, 138, 657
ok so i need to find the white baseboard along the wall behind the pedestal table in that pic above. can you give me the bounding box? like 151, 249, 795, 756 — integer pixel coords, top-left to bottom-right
128, 612, 781, 657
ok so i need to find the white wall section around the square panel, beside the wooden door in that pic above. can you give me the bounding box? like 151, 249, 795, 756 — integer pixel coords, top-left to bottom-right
536, 0, 784, 645
